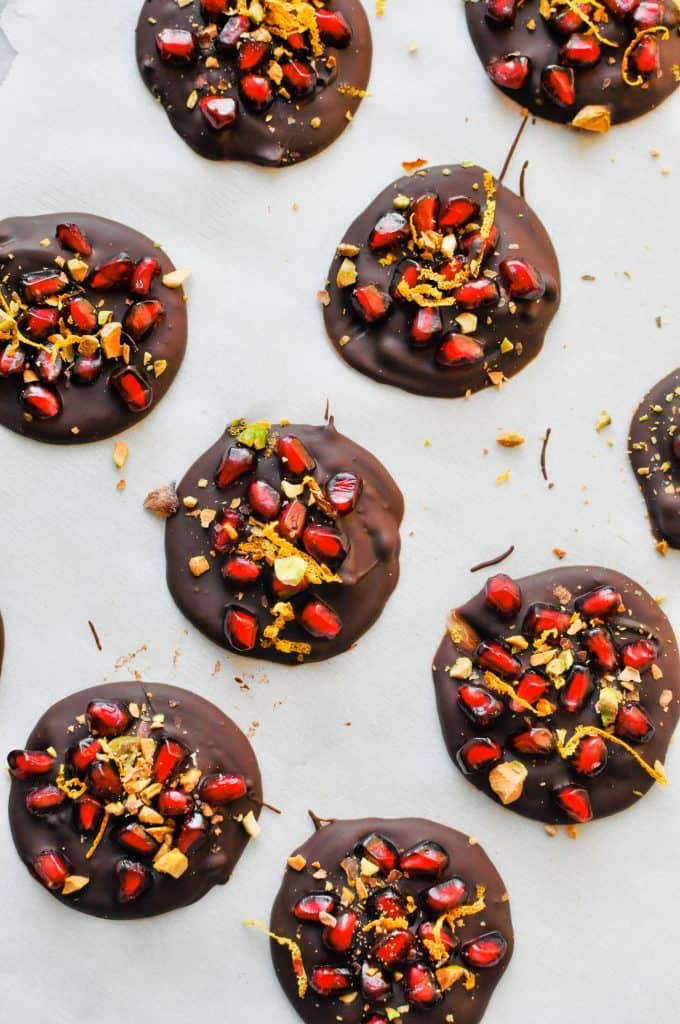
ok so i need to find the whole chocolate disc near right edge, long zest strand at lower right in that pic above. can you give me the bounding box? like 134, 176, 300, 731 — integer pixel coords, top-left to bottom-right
433, 565, 680, 824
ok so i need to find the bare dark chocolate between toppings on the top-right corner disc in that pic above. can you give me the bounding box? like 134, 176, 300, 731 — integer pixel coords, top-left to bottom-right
464, 0, 680, 124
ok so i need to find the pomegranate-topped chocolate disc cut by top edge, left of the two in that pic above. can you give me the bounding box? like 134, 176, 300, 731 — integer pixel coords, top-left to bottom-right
137, 0, 372, 167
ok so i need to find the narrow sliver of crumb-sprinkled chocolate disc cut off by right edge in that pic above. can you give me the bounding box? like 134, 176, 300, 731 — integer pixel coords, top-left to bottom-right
628, 370, 680, 548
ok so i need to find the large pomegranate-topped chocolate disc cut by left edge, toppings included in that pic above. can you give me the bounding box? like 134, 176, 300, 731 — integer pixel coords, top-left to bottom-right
0, 213, 186, 444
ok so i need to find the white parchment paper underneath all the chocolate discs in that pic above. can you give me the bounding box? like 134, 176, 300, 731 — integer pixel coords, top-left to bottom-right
0, 0, 680, 1024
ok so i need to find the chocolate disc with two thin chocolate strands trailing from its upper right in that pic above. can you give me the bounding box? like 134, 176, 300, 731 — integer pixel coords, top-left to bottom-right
324, 165, 560, 398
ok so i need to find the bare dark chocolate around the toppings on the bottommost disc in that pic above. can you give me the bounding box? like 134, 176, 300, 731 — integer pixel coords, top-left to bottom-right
270, 818, 514, 1024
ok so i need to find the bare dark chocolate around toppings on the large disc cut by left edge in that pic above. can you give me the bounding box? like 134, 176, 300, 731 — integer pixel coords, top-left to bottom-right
0, 213, 186, 444
